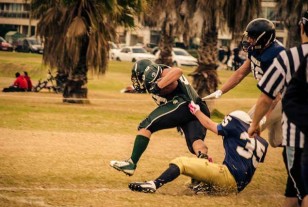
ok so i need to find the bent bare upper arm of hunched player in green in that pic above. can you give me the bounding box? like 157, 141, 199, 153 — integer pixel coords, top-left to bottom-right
157, 67, 183, 89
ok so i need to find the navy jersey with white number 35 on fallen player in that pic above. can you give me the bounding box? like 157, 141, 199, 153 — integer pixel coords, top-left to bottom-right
217, 116, 268, 192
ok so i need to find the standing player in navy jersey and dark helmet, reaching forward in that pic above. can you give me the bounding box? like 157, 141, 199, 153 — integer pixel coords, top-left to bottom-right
203, 18, 284, 147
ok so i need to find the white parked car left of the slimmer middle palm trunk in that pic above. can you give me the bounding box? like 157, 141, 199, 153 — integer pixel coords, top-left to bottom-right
116, 46, 155, 62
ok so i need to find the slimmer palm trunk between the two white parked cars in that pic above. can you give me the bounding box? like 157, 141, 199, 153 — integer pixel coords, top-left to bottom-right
156, 15, 174, 66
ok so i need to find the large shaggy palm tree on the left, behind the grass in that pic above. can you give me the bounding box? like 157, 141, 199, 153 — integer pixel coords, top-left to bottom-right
31, 0, 144, 103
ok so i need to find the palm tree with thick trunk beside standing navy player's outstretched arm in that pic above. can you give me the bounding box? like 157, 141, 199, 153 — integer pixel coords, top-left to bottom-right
189, 0, 261, 96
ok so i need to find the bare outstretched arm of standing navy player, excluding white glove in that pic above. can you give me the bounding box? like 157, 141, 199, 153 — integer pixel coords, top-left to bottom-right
220, 59, 251, 94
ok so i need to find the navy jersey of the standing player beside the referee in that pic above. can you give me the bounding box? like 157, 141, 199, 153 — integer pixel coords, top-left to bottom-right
248, 40, 284, 81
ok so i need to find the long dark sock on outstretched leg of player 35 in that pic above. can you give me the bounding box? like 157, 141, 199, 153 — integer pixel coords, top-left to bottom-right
154, 164, 181, 189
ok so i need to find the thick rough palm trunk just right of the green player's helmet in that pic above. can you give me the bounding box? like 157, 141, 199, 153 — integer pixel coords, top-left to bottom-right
189, 23, 219, 97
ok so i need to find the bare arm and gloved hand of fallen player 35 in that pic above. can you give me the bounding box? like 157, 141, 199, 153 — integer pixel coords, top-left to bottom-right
189, 101, 218, 134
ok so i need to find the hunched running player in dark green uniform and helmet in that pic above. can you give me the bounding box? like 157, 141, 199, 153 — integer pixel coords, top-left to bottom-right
110, 60, 210, 176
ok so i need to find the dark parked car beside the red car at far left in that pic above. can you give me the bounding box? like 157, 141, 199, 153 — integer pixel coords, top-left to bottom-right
15, 38, 44, 54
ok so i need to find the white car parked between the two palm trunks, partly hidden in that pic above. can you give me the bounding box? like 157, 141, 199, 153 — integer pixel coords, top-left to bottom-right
155, 47, 198, 66
